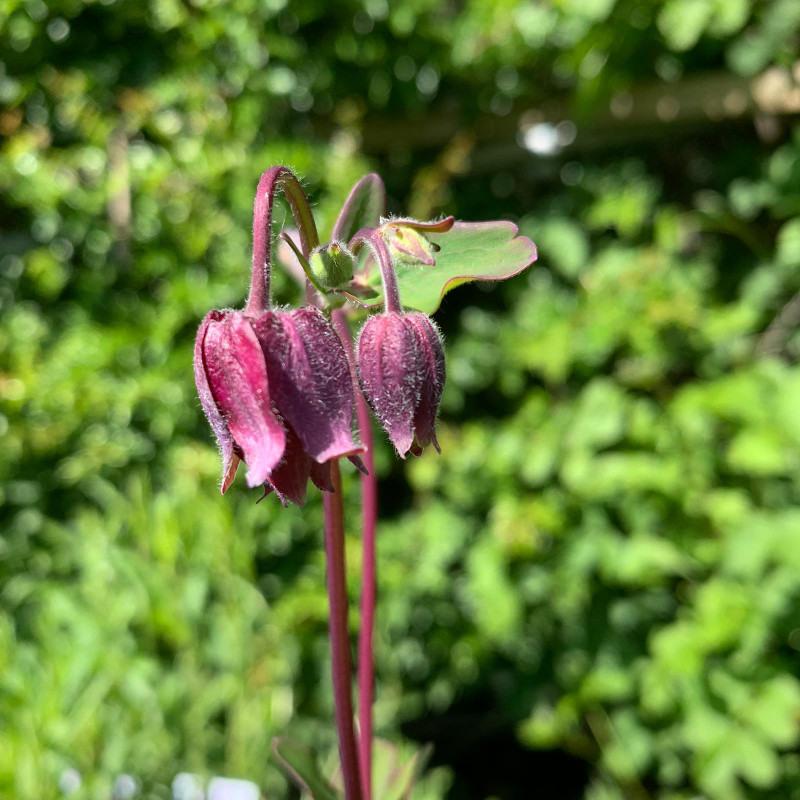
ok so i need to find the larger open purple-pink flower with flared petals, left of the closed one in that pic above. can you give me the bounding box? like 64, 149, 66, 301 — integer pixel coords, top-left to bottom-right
195, 306, 362, 505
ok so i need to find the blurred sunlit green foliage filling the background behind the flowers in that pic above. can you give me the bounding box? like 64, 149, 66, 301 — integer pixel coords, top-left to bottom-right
0, 0, 800, 800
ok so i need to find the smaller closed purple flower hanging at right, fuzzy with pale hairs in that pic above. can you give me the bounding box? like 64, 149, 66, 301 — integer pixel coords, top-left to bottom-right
356, 311, 445, 457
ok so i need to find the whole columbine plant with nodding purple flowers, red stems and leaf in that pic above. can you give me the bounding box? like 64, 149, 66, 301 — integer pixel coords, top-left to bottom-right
194, 167, 536, 800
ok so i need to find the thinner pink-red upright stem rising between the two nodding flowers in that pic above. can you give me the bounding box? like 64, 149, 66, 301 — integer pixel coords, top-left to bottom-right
331, 309, 378, 800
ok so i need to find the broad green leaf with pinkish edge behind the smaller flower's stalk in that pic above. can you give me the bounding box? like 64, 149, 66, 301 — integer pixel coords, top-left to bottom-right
345, 221, 536, 314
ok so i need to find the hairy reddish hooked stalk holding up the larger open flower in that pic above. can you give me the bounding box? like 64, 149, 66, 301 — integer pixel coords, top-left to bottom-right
245, 167, 319, 315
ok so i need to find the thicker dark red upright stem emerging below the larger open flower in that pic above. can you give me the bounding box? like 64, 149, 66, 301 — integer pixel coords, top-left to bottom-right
322, 460, 362, 800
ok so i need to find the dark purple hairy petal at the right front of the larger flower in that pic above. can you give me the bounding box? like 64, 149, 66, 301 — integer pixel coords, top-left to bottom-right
253, 306, 363, 464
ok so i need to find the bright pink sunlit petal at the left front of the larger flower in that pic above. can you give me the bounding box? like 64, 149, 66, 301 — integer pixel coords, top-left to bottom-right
202, 311, 286, 487
